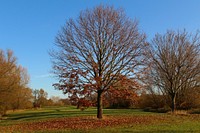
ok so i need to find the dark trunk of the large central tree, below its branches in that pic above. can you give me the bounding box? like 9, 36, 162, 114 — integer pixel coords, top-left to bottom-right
97, 90, 103, 119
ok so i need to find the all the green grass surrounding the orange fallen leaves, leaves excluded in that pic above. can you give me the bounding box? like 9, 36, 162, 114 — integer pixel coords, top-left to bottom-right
0, 106, 200, 133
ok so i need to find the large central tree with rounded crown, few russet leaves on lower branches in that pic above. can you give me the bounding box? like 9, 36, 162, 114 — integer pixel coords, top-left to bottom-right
50, 5, 146, 119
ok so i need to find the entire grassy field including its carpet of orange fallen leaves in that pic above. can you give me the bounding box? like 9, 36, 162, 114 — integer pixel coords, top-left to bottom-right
0, 107, 200, 133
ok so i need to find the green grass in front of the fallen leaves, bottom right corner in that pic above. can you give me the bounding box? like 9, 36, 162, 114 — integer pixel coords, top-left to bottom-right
101, 119, 200, 133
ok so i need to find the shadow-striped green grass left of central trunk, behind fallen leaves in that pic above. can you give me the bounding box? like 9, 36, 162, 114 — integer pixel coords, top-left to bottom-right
0, 106, 92, 126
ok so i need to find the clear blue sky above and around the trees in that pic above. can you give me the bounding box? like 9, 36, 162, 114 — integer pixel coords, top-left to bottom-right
0, 0, 200, 97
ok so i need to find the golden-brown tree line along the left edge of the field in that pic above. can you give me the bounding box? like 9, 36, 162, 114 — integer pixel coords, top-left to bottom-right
0, 50, 68, 118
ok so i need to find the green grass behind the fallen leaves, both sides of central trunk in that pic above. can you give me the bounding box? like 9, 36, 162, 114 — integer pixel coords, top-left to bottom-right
0, 106, 151, 125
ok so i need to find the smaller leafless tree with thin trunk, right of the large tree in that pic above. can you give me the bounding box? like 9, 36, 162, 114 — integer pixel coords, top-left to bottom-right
148, 30, 200, 112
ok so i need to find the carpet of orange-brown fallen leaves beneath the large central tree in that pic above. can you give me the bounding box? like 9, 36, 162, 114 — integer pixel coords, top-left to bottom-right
0, 116, 158, 132
